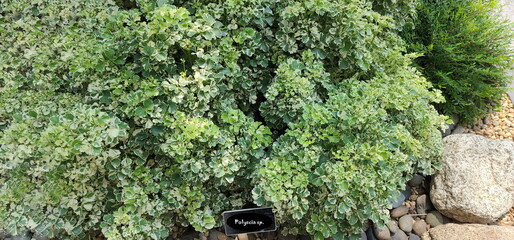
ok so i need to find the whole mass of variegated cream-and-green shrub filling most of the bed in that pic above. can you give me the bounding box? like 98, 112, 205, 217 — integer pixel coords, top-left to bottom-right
0, 0, 444, 239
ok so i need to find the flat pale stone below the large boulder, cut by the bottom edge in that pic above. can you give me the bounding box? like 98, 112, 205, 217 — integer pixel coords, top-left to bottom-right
423, 223, 514, 240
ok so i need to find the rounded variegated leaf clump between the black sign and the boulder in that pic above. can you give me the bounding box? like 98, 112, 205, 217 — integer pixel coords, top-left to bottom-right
253, 51, 444, 239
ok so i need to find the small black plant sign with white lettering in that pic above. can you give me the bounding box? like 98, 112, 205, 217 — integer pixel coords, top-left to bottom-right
223, 208, 276, 235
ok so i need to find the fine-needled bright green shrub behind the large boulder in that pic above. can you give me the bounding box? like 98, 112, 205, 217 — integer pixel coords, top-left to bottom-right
404, 0, 513, 123
